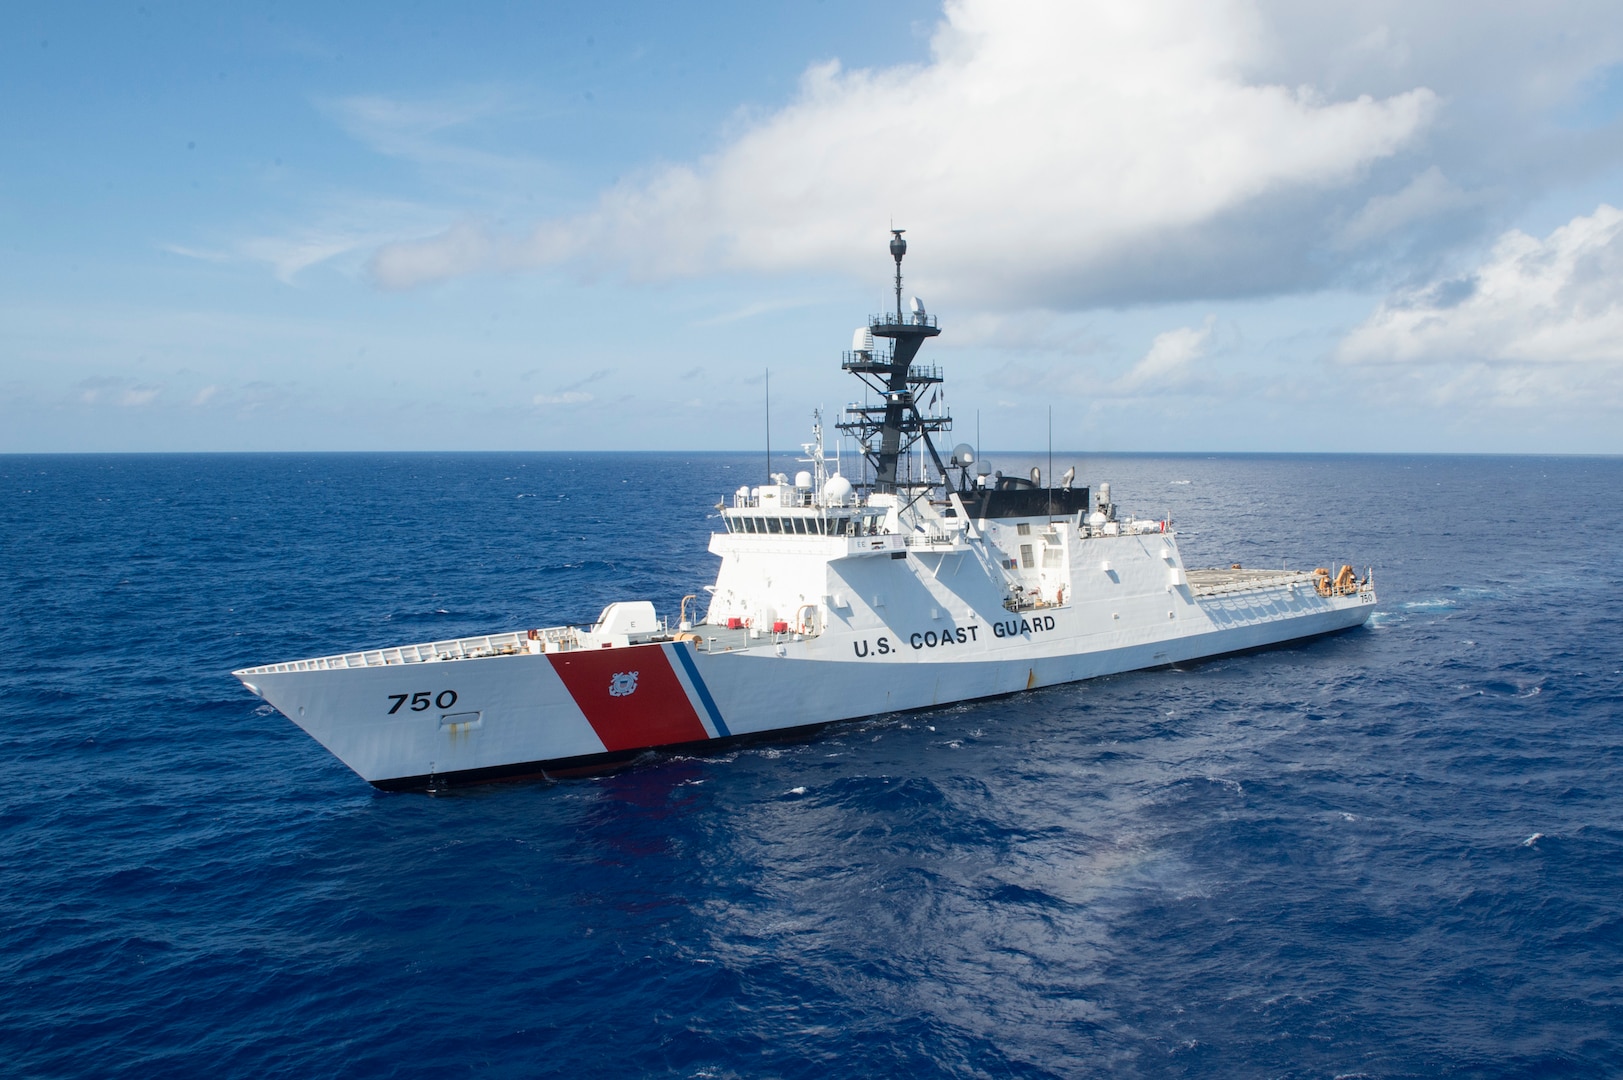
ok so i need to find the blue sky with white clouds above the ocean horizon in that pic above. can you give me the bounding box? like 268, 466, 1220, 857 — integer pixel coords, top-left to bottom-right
0, 0, 1623, 453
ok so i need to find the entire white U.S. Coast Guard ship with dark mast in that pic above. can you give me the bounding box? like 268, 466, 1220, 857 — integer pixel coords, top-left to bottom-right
232, 231, 1375, 789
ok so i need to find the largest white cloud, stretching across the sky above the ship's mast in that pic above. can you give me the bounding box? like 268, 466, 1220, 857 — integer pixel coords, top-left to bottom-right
373, 0, 1436, 298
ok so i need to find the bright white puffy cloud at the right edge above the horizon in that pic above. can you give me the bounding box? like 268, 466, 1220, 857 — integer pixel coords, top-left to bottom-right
1339, 205, 1623, 404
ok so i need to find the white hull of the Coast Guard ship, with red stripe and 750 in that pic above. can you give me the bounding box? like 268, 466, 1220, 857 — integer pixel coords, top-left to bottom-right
237, 590, 1373, 789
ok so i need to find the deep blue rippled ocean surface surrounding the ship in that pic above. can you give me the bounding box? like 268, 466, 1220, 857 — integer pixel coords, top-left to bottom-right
0, 453, 1623, 1080
